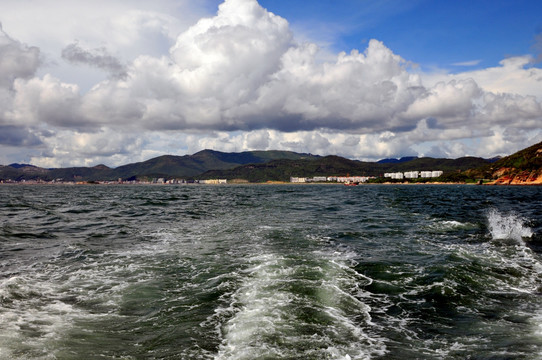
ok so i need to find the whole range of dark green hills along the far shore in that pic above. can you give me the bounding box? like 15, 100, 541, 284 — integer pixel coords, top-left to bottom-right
0, 143, 542, 183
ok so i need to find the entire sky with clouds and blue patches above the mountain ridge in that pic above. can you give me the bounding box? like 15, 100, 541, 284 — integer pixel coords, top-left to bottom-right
0, 0, 542, 167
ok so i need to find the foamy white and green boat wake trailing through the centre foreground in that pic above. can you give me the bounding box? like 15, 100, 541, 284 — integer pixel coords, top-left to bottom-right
216, 239, 386, 359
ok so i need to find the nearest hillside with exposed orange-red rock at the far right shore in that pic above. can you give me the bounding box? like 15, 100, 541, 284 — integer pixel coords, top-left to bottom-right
467, 142, 542, 185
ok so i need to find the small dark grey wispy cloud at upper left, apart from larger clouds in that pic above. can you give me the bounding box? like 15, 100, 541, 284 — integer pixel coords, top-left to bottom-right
62, 42, 127, 79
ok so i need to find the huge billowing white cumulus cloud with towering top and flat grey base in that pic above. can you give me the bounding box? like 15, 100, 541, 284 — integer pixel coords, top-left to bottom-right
83, 0, 542, 138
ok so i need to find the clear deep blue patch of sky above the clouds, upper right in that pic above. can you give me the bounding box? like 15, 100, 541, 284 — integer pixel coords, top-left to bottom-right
260, 0, 542, 71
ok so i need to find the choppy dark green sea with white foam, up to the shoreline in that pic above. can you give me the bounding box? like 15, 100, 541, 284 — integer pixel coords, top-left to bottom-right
0, 185, 542, 360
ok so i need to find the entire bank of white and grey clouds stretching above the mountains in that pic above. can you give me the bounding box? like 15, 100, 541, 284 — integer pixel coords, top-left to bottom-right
0, 0, 542, 165
